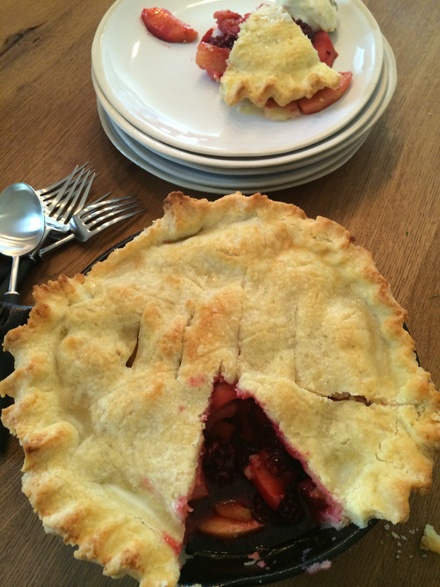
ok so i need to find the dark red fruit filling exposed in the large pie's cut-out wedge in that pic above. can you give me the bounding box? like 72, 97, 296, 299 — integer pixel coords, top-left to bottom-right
188, 380, 339, 540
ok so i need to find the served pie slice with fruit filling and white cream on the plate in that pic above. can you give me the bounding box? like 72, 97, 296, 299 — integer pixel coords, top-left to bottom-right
195, 0, 353, 121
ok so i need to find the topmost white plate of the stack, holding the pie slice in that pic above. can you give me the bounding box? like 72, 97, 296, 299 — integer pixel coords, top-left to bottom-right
92, 0, 383, 157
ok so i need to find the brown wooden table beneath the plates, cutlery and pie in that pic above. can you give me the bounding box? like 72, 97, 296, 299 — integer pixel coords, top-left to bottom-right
0, 0, 440, 587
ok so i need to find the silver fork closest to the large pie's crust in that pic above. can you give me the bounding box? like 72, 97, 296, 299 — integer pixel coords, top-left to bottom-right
38, 192, 143, 257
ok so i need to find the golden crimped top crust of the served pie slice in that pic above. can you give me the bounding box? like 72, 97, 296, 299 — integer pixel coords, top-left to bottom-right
220, 5, 341, 108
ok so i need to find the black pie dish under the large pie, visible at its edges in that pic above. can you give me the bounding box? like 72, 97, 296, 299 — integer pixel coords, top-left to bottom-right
82, 232, 378, 587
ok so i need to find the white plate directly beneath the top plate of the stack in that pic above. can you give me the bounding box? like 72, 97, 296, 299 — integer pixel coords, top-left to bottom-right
92, 39, 397, 177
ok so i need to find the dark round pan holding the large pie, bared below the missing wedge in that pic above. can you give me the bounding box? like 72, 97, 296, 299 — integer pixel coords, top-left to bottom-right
83, 233, 376, 587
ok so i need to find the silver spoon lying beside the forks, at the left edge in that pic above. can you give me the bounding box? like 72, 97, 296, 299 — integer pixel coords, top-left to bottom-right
0, 183, 45, 303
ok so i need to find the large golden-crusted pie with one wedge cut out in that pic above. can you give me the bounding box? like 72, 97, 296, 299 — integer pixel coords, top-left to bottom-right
0, 192, 440, 587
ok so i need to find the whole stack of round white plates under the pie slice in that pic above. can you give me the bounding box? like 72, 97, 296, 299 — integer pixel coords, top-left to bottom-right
92, 0, 397, 194
